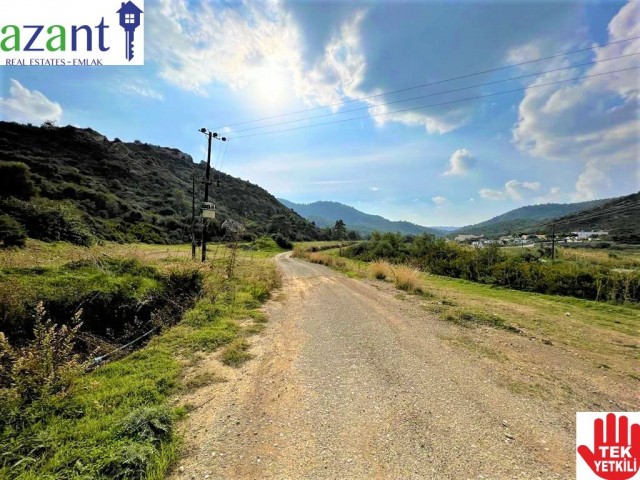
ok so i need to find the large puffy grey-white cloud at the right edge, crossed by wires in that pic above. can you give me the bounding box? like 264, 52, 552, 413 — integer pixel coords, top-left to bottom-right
513, 0, 640, 200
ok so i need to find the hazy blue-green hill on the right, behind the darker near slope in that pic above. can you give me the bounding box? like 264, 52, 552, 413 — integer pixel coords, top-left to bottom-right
455, 199, 608, 237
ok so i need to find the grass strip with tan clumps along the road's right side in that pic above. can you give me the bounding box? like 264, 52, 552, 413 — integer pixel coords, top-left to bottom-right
298, 250, 640, 381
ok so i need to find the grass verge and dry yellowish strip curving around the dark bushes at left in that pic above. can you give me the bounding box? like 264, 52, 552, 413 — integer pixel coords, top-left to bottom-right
0, 241, 281, 480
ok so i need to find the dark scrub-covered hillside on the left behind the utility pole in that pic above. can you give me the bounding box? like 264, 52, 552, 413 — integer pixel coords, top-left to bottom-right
0, 122, 323, 243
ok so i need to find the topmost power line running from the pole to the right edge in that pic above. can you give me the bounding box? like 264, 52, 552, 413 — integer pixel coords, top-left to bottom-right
214, 36, 640, 130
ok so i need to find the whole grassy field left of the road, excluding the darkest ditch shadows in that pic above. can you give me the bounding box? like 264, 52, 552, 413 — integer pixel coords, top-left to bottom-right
0, 241, 280, 479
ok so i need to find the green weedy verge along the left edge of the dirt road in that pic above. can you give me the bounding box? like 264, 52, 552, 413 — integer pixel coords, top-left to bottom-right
0, 242, 279, 480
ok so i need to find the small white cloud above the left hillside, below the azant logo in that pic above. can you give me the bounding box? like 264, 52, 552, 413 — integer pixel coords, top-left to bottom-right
0, 79, 62, 123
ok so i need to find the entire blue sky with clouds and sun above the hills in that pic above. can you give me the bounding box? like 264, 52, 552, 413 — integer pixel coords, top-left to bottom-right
0, 0, 640, 225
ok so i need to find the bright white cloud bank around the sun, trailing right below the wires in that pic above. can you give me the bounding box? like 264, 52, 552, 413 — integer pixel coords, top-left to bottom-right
148, 0, 470, 134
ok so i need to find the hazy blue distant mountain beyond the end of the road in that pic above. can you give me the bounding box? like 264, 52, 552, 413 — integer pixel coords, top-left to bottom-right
278, 198, 443, 235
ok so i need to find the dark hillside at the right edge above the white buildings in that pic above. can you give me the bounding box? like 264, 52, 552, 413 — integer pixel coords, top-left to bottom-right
542, 192, 640, 244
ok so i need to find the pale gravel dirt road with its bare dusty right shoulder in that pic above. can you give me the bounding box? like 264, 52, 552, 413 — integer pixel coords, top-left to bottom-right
170, 253, 632, 480
